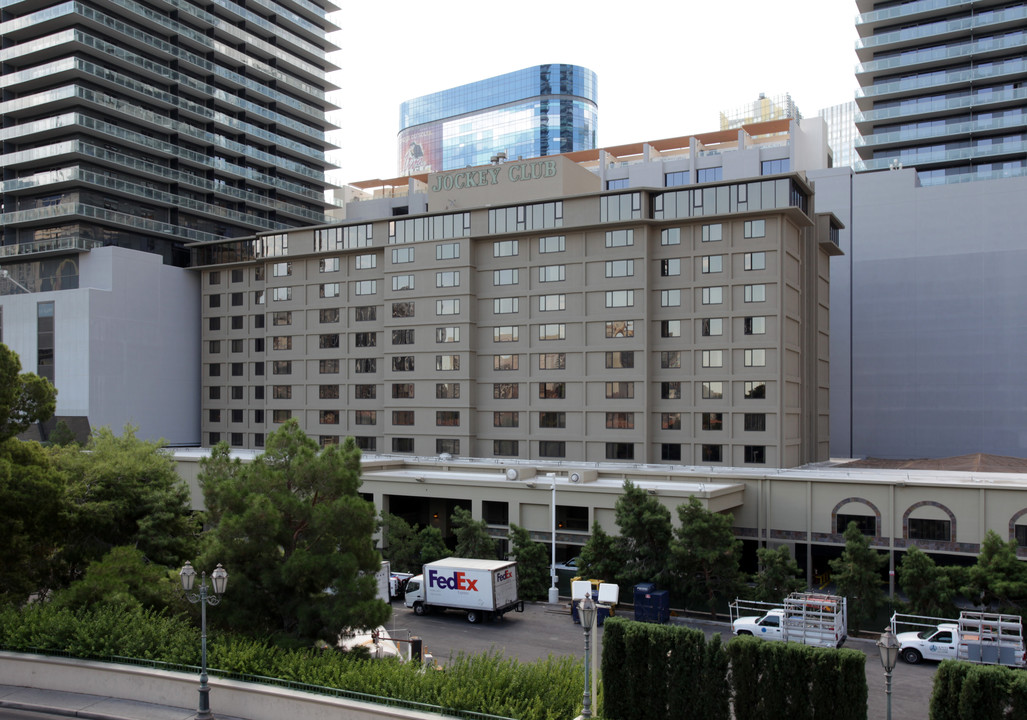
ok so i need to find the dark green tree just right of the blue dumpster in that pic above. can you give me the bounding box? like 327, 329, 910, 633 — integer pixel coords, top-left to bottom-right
670, 496, 743, 619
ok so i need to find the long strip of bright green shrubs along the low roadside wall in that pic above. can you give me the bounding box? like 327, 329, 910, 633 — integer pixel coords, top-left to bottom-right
0, 605, 584, 720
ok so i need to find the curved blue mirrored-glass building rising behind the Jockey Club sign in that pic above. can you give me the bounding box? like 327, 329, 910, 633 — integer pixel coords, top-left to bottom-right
400, 65, 598, 175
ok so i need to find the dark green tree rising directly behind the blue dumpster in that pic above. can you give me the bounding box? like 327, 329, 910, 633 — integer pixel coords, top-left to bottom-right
614, 480, 672, 586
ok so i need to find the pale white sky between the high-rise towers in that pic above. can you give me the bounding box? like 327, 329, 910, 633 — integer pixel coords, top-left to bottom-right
329, 0, 857, 183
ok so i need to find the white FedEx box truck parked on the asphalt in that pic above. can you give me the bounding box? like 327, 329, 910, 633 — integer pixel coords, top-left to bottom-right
404, 558, 524, 622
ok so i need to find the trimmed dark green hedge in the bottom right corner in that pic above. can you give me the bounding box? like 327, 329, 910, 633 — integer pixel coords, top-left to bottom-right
930, 660, 1027, 720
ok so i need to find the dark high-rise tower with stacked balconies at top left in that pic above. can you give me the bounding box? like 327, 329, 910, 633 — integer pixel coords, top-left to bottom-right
0, 0, 338, 293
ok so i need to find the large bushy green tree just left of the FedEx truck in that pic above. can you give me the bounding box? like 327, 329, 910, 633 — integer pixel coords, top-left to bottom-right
196, 419, 389, 640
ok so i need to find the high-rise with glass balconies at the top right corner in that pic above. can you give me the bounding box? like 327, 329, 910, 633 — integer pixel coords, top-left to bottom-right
857, 0, 1027, 185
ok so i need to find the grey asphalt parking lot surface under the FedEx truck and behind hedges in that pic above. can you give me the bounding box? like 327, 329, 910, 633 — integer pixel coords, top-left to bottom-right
386, 602, 938, 720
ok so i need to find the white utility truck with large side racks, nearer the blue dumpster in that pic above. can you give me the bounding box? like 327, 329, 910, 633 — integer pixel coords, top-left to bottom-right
728, 593, 848, 647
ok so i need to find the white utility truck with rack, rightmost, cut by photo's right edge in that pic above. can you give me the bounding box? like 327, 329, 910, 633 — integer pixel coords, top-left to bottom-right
891, 610, 1027, 668
